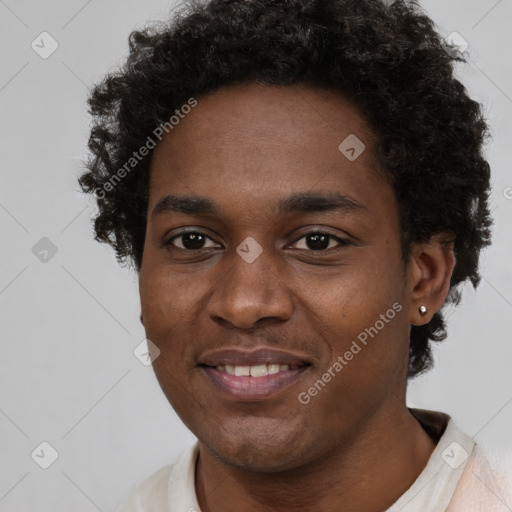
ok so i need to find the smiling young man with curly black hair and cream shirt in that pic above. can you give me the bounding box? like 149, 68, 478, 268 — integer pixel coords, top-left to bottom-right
80, 0, 509, 512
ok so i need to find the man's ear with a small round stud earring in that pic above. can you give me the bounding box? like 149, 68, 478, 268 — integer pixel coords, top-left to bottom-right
408, 233, 455, 325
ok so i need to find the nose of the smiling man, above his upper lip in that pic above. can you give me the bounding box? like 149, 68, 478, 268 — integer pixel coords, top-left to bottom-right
208, 245, 293, 329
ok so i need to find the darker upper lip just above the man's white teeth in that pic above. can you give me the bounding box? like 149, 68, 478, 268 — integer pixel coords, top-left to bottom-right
198, 347, 311, 366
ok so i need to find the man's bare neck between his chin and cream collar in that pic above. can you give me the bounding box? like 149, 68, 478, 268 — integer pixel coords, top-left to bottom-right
196, 405, 435, 512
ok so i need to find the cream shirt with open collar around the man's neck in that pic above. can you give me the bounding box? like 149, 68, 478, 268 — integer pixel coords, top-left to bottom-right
117, 409, 512, 512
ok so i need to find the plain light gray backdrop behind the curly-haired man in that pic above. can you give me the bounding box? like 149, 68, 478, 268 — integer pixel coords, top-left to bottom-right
0, 0, 512, 512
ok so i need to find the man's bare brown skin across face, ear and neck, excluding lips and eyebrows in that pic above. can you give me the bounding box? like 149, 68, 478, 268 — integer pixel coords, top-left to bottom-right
140, 83, 455, 512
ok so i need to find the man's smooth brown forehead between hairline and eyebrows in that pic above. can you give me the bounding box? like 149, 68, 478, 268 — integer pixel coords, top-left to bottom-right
150, 83, 384, 212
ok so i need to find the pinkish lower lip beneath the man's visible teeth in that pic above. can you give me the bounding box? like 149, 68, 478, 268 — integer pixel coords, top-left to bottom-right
201, 366, 309, 401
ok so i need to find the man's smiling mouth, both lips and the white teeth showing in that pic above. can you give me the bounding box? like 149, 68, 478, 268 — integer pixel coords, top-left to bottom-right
198, 349, 312, 402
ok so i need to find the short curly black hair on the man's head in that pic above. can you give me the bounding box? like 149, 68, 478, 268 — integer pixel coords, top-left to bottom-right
79, 0, 492, 378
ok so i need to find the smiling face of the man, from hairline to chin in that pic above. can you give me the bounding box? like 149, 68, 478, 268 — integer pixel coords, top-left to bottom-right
140, 84, 409, 471
